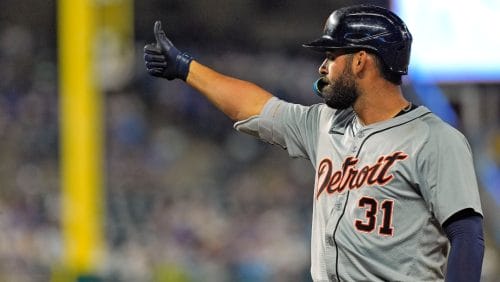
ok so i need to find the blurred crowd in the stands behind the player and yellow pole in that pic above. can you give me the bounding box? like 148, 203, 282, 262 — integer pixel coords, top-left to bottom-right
0, 1, 500, 282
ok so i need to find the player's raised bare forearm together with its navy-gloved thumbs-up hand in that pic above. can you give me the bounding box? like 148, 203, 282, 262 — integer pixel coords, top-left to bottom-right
144, 21, 272, 121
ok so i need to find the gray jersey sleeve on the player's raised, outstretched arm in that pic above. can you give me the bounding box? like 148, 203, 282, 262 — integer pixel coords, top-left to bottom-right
234, 97, 320, 159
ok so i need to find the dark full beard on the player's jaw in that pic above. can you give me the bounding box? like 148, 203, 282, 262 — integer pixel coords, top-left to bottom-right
320, 67, 359, 110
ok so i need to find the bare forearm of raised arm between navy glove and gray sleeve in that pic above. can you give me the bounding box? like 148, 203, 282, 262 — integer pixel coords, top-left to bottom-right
186, 61, 272, 121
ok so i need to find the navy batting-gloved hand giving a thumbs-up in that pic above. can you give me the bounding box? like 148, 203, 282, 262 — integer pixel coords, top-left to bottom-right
144, 21, 193, 81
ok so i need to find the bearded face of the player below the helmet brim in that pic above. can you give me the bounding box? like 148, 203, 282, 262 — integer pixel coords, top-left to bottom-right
320, 54, 359, 110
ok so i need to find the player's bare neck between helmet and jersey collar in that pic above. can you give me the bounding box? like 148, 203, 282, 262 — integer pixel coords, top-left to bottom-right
353, 82, 410, 125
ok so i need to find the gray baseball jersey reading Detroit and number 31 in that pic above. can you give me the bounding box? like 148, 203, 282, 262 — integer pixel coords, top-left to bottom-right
235, 98, 482, 281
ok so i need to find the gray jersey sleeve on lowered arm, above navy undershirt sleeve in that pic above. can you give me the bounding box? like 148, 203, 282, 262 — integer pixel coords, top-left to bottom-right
417, 121, 482, 225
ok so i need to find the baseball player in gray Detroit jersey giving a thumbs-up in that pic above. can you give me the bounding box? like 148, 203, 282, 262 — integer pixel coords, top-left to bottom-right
144, 5, 484, 281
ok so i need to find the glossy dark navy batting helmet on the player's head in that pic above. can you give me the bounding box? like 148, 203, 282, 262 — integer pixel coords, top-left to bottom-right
303, 5, 412, 75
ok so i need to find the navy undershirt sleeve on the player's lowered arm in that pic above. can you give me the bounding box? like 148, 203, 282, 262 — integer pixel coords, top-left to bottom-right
443, 210, 484, 282
